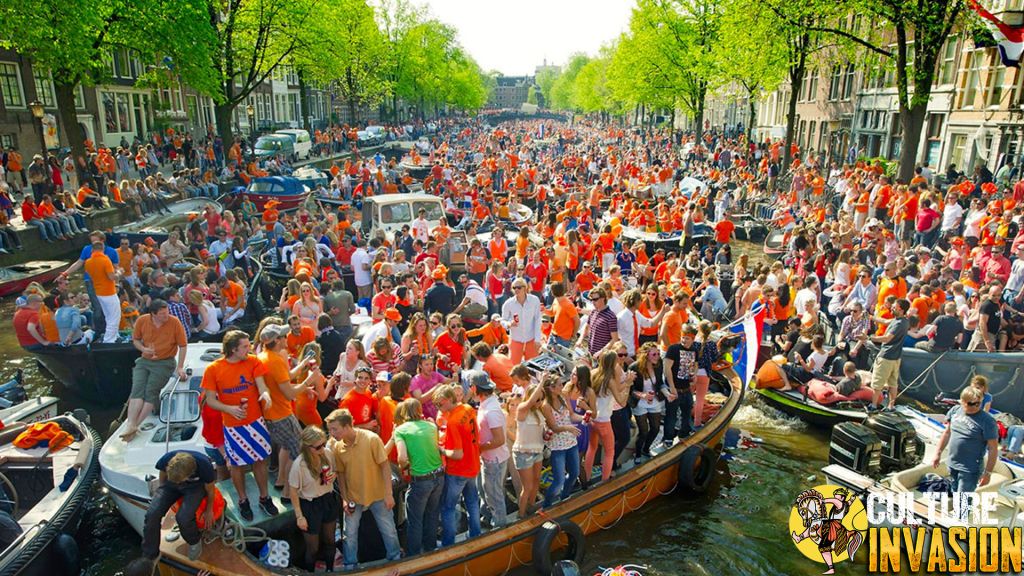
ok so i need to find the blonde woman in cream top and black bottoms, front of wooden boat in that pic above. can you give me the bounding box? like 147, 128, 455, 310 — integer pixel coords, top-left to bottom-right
288, 426, 338, 571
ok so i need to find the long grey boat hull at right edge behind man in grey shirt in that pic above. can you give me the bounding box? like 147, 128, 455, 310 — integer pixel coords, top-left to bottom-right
899, 347, 1024, 416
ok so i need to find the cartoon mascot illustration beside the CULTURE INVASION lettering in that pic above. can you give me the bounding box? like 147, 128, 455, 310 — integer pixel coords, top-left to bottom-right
793, 488, 863, 574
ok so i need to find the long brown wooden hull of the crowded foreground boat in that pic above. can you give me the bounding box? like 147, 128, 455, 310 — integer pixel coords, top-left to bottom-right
161, 369, 744, 576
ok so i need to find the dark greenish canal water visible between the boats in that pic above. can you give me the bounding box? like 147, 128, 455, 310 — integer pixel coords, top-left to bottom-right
0, 239, 905, 576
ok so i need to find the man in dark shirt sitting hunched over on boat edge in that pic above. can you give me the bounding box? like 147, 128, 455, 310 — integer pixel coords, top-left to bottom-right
142, 450, 217, 560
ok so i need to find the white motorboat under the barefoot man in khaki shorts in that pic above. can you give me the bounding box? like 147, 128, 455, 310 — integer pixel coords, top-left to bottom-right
99, 343, 292, 535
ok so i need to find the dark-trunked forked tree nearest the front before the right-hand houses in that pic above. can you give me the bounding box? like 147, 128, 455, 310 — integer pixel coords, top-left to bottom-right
776, 0, 966, 181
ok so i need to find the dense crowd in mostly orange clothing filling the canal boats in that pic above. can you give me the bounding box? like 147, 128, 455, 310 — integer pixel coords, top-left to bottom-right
15, 109, 1024, 568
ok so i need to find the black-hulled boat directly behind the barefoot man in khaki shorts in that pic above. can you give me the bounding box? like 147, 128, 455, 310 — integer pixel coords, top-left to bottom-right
32, 257, 263, 407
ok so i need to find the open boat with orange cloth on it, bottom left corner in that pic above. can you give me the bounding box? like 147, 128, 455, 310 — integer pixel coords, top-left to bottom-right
0, 411, 102, 576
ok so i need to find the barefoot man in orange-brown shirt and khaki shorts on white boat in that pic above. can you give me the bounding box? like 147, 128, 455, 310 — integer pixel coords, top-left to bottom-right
121, 299, 188, 442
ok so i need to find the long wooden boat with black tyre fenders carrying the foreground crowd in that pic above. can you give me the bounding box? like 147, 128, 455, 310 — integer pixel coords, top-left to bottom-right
151, 368, 744, 576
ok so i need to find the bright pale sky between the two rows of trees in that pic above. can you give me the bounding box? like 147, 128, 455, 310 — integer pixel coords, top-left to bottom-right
421, 0, 634, 76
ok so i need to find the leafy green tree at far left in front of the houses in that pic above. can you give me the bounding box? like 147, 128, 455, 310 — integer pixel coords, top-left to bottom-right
0, 0, 215, 177
